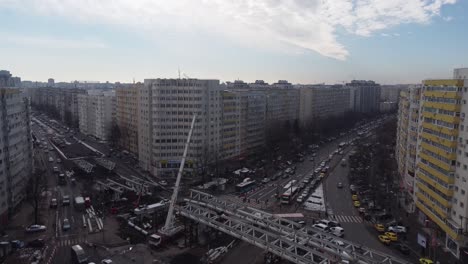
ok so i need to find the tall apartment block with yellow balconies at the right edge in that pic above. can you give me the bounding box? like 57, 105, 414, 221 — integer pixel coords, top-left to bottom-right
396, 69, 468, 257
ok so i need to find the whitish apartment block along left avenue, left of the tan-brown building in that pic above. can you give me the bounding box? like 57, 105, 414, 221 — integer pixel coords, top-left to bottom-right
78, 90, 115, 141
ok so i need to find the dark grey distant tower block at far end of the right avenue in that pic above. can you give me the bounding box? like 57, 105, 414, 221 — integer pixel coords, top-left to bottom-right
346, 80, 381, 113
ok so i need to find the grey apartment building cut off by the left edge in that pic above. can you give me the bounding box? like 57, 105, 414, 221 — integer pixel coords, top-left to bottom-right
0, 88, 33, 226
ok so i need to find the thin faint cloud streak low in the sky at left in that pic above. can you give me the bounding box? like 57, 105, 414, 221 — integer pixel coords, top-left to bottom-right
3, 34, 106, 49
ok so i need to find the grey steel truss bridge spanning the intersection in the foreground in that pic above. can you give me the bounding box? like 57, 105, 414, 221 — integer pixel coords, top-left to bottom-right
178, 190, 410, 264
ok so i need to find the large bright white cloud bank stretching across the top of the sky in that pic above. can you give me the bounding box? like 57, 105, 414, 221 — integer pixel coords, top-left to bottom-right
0, 0, 457, 60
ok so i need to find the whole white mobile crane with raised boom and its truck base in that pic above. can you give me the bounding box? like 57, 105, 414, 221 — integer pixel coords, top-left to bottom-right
149, 115, 196, 247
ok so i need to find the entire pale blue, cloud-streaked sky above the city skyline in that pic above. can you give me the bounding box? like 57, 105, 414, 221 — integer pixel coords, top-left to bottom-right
0, 0, 468, 84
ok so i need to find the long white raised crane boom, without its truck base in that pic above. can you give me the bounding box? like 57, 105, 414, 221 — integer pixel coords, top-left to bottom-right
160, 115, 196, 235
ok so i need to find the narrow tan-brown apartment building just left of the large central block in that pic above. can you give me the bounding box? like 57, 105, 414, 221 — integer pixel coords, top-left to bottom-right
115, 83, 143, 154
